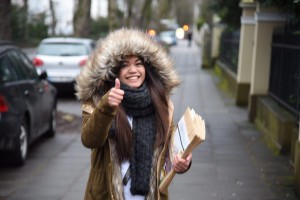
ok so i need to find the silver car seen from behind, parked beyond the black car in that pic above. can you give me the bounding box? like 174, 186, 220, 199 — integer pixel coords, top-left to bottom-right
33, 37, 95, 92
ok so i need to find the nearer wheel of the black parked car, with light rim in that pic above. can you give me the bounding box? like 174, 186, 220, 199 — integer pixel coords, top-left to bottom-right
14, 120, 28, 166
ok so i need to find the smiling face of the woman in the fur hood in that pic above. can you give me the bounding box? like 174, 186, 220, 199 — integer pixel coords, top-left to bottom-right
118, 56, 146, 88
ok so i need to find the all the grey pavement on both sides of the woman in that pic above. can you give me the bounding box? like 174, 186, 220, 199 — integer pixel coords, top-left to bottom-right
0, 41, 297, 200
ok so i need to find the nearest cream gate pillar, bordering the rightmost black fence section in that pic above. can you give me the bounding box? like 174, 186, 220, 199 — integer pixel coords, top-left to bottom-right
248, 3, 286, 122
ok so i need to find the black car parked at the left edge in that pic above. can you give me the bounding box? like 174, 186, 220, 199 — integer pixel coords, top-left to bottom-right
0, 41, 57, 165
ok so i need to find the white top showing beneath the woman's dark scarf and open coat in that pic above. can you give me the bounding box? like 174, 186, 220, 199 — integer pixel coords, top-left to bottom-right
121, 116, 145, 200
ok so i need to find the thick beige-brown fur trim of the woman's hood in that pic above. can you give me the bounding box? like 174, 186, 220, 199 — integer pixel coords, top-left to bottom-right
76, 28, 180, 100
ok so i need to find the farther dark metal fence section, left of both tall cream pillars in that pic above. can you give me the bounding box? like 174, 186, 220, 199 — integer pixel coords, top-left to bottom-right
219, 31, 240, 74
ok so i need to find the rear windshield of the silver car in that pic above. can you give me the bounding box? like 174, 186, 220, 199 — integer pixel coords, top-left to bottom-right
37, 43, 88, 56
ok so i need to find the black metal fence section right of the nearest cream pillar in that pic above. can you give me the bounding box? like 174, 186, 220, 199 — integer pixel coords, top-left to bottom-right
269, 26, 300, 119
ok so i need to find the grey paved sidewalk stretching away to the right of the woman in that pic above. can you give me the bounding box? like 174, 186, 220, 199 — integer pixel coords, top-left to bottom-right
169, 41, 297, 200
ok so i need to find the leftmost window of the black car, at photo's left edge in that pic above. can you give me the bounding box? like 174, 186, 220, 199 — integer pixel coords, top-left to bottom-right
0, 55, 17, 84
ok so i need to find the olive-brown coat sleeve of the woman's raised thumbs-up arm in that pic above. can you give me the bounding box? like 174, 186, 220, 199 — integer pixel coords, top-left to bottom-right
81, 93, 117, 148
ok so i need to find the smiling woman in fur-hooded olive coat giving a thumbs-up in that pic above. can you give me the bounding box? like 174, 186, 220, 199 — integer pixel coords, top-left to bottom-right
76, 28, 192, 200
